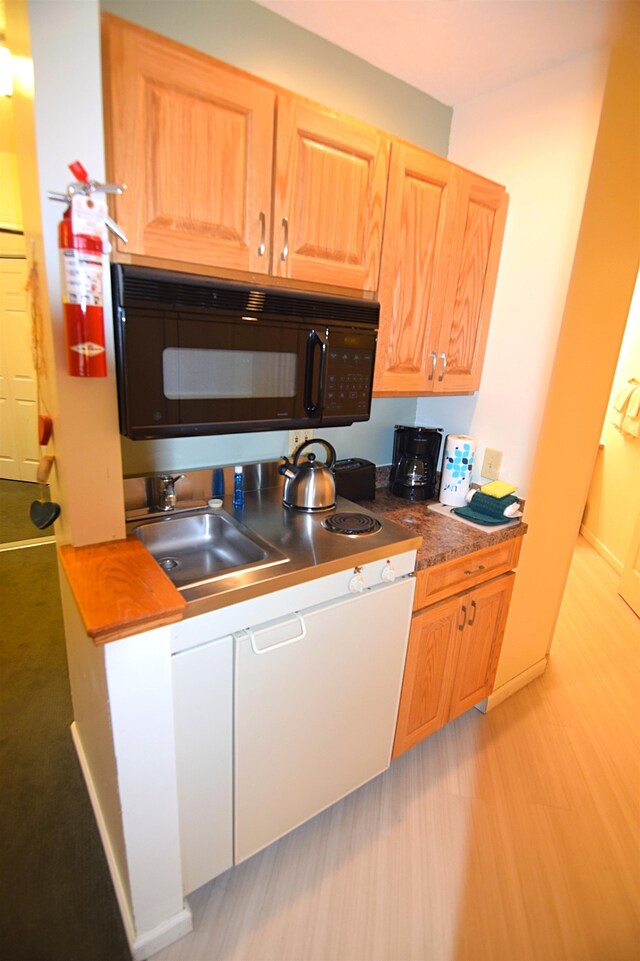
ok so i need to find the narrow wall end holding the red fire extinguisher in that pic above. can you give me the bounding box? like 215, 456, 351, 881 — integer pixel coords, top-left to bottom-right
7, 0, 124, 546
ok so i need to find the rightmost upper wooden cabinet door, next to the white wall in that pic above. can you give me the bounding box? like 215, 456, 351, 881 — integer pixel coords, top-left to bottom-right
434, 171, 509, 394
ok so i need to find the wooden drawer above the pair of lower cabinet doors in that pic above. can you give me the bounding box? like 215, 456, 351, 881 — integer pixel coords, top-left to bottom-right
413, 537, 522, 611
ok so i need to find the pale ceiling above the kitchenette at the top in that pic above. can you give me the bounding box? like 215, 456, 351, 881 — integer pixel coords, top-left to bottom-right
256, 0, 619, 106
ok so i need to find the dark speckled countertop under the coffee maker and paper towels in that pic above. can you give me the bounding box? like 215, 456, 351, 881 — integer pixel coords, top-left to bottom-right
360, 469, 527, 570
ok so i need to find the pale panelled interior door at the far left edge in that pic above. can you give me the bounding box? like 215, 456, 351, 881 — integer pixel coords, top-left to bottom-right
0, 257, 40, 481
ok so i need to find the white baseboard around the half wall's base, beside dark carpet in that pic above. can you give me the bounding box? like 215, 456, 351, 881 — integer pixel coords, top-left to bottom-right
71, 721, 193, 961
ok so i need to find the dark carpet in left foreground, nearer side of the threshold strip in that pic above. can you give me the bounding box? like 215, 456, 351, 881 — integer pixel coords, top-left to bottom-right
0, 545, 131, 961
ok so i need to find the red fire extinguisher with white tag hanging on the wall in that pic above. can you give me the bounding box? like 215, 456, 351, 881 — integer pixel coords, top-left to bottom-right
49, 161, 126, 377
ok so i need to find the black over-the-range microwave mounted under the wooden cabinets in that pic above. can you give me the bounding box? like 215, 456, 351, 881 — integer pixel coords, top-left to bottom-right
112, 264, 379, 440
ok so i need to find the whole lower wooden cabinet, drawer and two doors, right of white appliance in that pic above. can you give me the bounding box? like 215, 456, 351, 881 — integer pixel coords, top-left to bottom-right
392, 537, 522, 758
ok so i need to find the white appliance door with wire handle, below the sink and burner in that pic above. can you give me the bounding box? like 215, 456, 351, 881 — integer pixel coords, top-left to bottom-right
234, 578, 415, 864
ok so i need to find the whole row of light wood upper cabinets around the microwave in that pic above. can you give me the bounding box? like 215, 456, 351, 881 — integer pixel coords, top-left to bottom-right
103, 14, 508, 360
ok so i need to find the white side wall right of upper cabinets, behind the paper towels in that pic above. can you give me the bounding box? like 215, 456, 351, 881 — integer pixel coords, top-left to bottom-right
417, 54, 607, 496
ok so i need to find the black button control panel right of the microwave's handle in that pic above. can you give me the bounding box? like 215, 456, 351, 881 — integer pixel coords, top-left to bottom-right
323, 330, 376, 421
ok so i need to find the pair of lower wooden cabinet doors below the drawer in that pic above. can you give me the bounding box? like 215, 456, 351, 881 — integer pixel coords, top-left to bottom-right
392, 572, 515, 758
